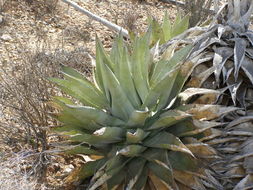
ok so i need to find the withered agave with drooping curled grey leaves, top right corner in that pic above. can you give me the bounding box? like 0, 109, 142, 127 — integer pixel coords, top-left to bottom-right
185, 0, 253, 107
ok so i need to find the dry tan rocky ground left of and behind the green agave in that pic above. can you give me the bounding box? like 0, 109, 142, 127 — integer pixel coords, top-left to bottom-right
0, 0, 176, 190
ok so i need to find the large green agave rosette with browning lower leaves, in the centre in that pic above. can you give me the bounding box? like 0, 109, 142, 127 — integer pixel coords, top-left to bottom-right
48, 33, 234, 190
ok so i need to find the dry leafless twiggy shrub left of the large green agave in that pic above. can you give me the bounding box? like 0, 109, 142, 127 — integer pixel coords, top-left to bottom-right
0, 46, 57, 180
